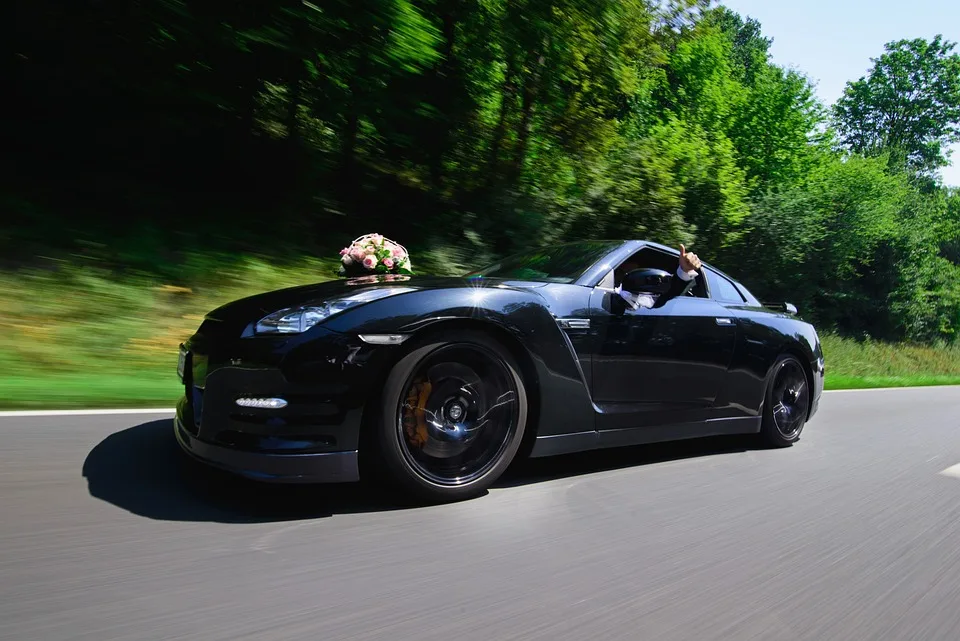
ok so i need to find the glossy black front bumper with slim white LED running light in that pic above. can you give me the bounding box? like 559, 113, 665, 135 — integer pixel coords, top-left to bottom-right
174, 324, 388, 483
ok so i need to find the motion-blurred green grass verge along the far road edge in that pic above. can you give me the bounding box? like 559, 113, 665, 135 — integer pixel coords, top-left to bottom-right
0, 253, 960, 409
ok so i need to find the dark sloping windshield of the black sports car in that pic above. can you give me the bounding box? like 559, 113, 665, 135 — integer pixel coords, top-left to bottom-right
466, 241, 620, 283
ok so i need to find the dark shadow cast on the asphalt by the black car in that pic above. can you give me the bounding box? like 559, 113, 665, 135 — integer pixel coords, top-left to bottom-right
82, 419, 757, 523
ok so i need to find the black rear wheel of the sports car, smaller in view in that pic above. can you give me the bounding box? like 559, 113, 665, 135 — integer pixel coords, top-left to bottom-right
760, 354, 810, 447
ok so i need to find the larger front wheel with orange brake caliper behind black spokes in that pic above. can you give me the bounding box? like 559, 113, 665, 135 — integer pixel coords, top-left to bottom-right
374, 330, 528, 503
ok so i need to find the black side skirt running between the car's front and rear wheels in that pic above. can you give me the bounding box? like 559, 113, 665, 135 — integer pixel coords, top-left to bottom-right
530, 416, 763, 458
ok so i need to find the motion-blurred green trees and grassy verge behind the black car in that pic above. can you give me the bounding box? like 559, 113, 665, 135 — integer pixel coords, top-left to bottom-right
0, 0, 960, 407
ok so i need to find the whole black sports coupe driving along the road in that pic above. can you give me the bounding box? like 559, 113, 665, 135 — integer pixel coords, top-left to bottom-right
174, 241, 824, 501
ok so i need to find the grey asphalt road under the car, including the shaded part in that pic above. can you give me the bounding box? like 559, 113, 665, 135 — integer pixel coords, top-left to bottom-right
0, 388, 960, 641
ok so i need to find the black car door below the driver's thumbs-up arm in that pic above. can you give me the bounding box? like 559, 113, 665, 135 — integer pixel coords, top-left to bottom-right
591, 268, 737, 429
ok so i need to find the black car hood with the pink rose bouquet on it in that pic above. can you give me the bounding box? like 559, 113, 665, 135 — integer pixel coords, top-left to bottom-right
207, 276, 547, 322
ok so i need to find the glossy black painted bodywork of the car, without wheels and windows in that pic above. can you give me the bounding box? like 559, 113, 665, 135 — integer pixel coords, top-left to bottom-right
176, 241, 823, 482
